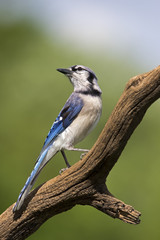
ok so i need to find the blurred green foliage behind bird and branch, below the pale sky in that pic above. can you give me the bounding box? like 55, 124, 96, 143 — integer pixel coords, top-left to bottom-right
0, 22, 160, 240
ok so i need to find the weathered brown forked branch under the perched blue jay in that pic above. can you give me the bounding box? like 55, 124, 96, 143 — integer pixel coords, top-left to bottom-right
0, 66, 160, 240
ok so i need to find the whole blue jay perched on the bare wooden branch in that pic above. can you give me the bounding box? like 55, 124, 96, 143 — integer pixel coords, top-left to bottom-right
13, 65, 102, 213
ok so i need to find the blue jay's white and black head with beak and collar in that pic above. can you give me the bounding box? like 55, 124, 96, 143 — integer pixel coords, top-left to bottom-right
57, 65, 102, 95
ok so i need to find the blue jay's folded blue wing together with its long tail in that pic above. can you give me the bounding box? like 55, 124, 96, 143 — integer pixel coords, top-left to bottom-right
13, 93, 83, 212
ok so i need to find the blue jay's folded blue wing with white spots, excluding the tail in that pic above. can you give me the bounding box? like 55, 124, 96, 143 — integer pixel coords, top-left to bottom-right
42, 93, 83, 151
